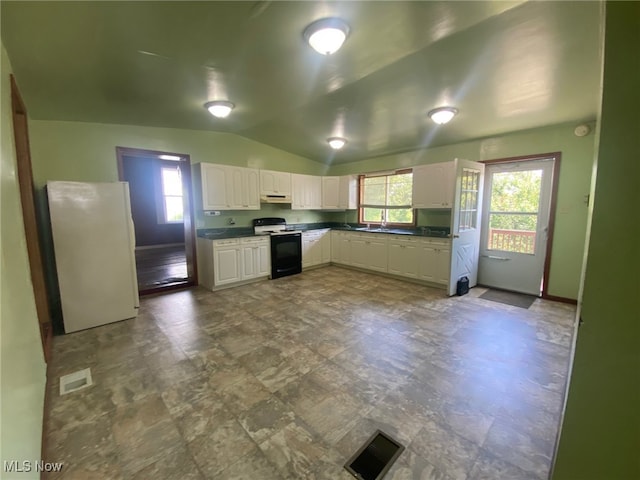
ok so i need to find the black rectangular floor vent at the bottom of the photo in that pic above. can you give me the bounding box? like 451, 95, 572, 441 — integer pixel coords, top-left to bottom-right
344, 430, 404, 480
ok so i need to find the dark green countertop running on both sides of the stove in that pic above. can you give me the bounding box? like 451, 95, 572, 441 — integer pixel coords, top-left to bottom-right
197, 222, 449, 240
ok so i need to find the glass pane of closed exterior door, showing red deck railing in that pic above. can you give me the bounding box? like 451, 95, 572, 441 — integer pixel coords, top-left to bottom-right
487, 170, 542, 255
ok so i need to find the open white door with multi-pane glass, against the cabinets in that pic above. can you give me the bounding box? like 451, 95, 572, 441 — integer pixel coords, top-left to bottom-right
449, 159, 484, 295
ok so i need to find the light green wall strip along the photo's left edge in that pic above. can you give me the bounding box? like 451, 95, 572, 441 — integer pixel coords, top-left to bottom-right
0, 44, 46, 479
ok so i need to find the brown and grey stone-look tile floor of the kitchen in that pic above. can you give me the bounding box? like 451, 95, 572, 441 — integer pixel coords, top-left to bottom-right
45, 267, 574, 480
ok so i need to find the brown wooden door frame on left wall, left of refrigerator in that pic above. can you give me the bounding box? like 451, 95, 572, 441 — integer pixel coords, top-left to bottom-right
10, 75, 53, 363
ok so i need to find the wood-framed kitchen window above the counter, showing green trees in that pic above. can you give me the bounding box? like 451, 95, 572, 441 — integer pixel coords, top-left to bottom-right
358, 170, 415, 226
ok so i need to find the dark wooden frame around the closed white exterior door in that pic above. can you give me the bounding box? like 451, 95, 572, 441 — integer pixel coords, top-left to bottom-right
481, 152, 576, 304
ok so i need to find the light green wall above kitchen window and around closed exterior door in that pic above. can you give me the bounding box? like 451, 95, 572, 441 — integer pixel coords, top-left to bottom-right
329, 124, 595, 299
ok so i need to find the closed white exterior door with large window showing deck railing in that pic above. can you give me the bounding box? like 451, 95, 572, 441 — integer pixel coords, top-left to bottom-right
479, 159, 554, 296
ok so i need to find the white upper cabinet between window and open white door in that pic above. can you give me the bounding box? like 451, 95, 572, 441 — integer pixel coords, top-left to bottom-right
413, 162, 456, 208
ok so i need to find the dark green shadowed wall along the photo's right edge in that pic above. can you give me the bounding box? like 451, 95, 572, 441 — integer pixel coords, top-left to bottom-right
553, 2, 640, 480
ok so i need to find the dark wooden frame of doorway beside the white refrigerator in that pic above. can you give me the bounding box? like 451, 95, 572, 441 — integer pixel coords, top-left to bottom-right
116, 147, 198, 295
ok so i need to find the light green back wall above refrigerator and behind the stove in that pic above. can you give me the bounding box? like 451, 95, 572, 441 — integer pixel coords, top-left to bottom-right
29, 120, 328, 228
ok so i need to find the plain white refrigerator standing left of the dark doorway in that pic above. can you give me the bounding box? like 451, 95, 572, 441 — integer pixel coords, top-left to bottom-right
47, 182, 139, 333
